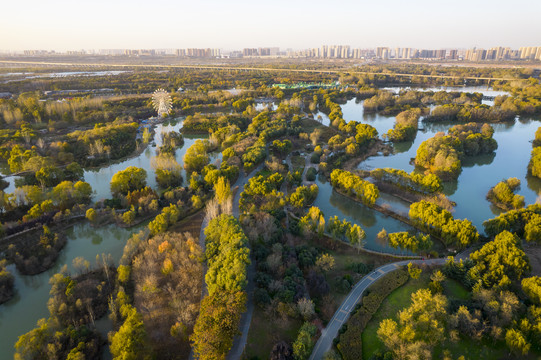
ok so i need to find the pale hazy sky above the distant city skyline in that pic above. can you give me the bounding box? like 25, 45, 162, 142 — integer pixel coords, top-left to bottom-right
0, 0, 541, 50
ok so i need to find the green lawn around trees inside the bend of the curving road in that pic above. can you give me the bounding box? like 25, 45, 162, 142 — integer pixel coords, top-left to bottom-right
362, 270, 508, 359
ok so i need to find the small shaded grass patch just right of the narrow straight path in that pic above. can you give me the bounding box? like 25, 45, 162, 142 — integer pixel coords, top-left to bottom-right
242, 306, 302, 359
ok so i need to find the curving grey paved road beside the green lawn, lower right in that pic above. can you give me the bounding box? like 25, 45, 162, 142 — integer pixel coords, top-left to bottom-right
310, 252, 467, 360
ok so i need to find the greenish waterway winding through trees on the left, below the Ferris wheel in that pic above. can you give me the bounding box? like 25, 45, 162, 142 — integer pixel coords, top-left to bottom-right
0, 119, 210, 360
